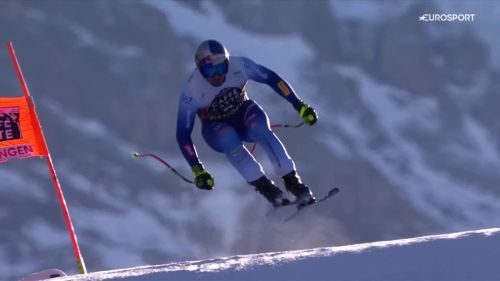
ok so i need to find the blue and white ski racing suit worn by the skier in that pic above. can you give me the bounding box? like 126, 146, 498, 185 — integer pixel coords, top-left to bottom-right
177, 56, 302, 183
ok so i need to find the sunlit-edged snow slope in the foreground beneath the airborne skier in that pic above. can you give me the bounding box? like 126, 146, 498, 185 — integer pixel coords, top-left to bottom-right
51, 228, 500, 281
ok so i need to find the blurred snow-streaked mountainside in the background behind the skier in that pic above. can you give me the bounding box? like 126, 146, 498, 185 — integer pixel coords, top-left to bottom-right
0, 0, 500, 280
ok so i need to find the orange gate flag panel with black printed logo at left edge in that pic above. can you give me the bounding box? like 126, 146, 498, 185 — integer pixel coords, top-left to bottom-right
0, 97, 48, 163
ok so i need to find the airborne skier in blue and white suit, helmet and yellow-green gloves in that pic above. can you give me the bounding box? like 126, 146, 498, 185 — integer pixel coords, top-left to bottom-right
177, 40, 318, 208
